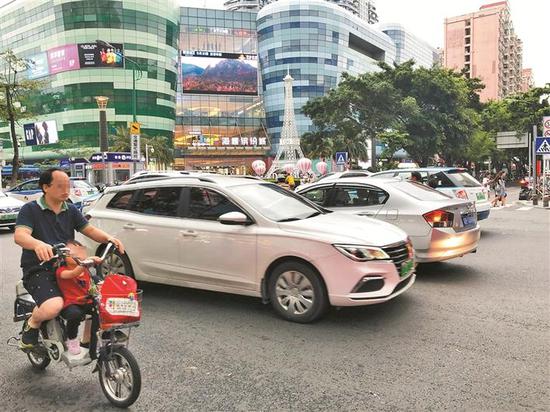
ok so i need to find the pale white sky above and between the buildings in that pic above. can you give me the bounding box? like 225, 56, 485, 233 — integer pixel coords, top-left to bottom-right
187, 0, 550, 86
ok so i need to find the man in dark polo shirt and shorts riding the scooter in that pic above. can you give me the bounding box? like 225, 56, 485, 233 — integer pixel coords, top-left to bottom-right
14, 168, 124, 350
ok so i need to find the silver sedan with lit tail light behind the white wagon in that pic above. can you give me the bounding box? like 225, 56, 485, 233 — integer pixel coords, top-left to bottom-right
296, 177, 480, 262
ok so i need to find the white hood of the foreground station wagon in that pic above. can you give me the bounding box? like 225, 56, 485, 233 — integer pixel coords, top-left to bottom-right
279, 213, 407, 246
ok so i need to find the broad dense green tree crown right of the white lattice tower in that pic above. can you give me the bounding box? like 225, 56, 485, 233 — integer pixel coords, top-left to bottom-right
303, 61, 483, 165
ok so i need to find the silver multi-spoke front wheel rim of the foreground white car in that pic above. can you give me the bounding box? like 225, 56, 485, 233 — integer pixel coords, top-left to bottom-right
275, 270, 315, 315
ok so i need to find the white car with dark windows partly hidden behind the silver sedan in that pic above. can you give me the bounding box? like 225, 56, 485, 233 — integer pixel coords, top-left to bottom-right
371, 167, 491, 220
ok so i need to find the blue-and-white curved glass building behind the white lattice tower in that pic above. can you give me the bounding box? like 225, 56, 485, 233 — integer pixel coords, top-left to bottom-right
257, 0, 395, 150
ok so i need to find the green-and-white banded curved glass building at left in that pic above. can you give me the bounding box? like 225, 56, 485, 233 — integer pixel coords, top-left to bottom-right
0, 0, 180, 159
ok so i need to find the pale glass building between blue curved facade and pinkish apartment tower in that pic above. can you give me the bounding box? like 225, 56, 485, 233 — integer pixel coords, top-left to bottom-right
378, 23, 439, 68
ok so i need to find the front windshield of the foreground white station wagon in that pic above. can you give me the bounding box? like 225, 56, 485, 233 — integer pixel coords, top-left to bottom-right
229, 183, 323, 222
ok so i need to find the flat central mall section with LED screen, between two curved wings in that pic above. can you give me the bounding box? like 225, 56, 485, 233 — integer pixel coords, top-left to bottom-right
174, 7, 269, 174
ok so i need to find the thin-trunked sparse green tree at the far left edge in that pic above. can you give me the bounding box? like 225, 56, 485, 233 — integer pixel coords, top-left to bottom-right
0, 50, 43, 185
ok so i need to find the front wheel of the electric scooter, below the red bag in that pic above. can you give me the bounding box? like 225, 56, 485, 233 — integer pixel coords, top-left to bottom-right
99, 346, 141, 408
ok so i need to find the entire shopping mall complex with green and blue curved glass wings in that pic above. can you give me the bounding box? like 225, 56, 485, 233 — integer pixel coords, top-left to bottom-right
0, 0, 440, 174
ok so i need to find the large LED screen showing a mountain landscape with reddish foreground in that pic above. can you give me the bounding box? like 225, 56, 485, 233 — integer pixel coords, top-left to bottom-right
181, 52, 258, 95
